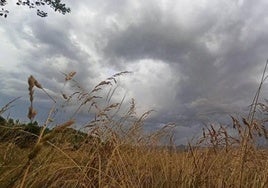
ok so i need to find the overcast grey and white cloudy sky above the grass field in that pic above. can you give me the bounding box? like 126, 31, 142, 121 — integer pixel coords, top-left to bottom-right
0, 0, 268, 143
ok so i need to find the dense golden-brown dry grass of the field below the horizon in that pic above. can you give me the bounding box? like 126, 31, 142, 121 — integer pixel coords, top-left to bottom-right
0, 137, 268, 187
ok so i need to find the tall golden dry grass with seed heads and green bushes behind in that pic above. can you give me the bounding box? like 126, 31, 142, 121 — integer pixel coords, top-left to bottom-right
0, 68, 268, 188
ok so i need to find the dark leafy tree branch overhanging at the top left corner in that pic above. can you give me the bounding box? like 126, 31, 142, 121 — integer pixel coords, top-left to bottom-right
0, 0, 71, 18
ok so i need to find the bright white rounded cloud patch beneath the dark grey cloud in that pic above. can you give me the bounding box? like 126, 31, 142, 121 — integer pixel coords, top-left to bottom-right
117, 59, 180, 115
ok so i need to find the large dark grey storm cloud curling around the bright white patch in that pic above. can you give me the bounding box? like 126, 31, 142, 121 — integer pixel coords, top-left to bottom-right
101, 2, 268, 130
